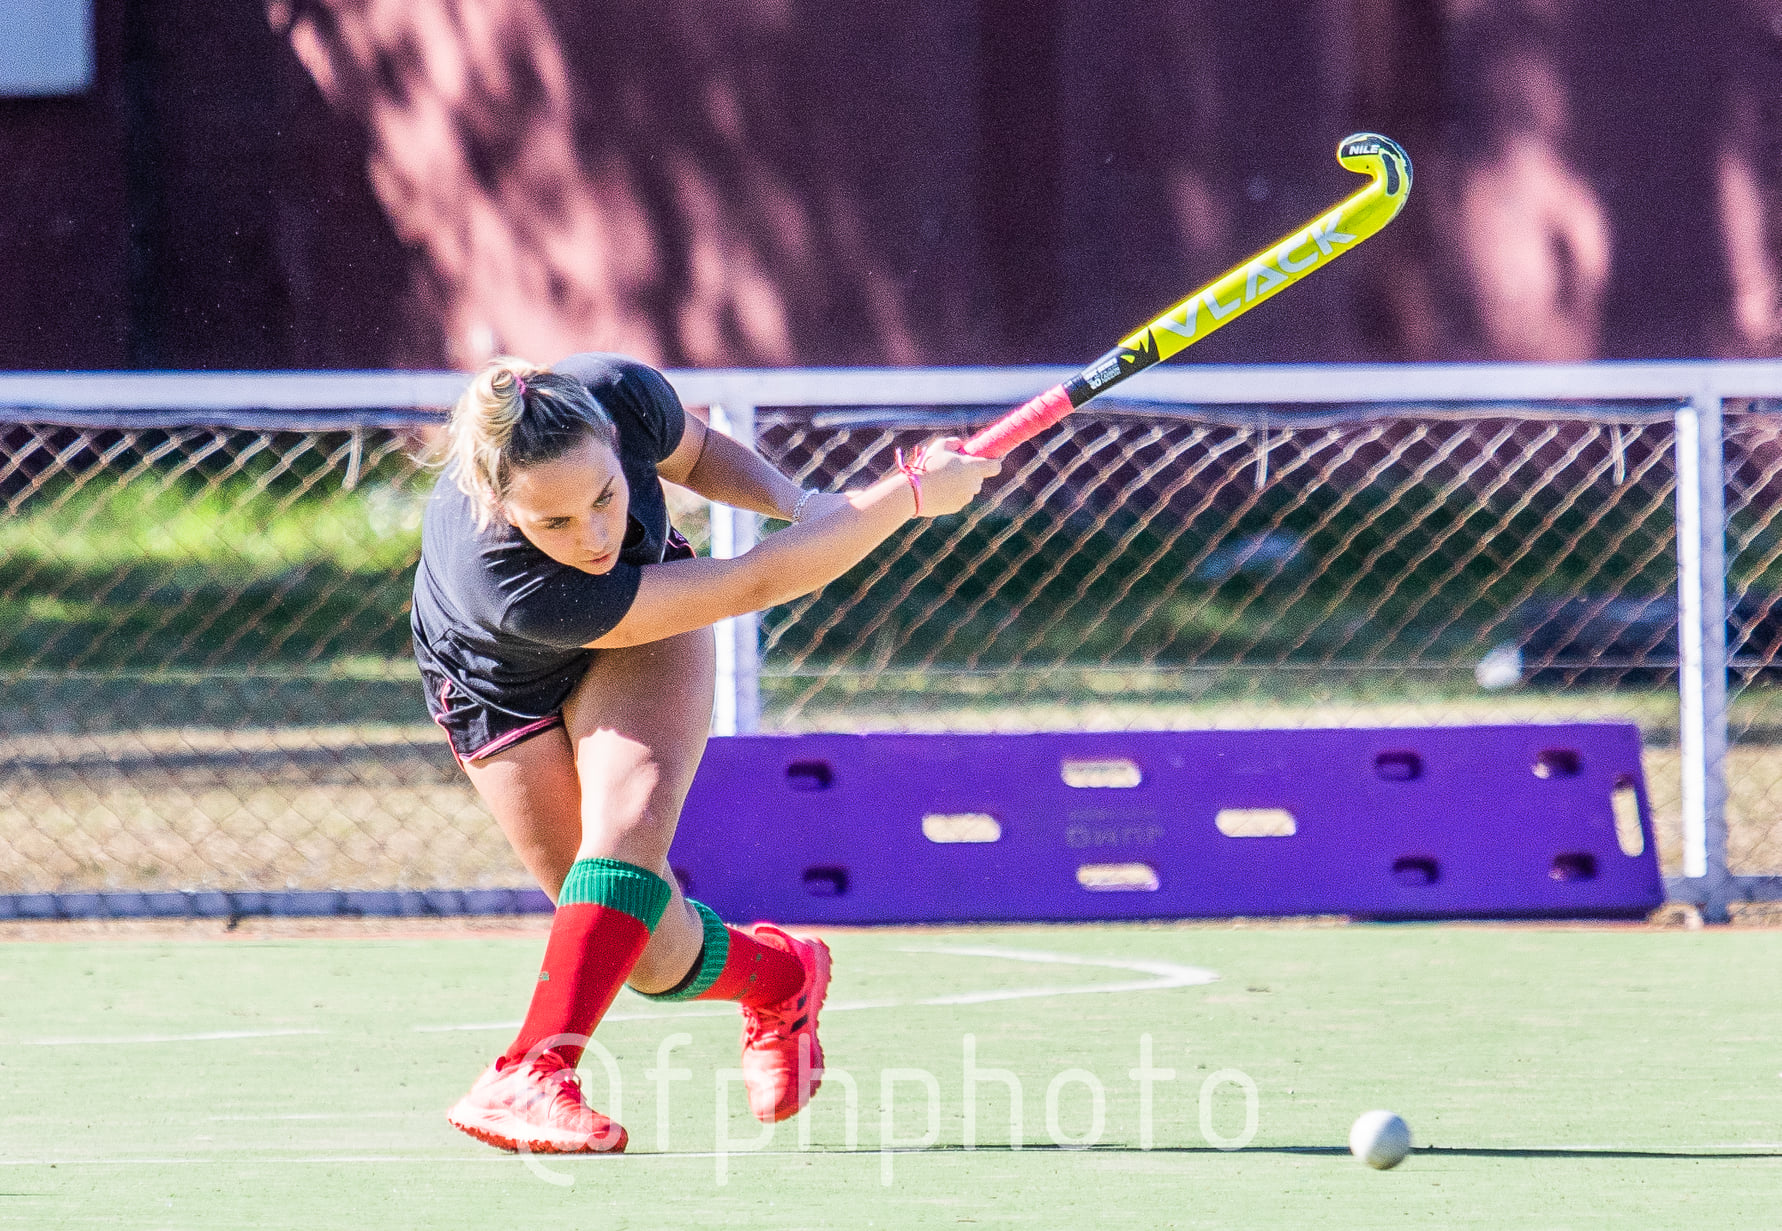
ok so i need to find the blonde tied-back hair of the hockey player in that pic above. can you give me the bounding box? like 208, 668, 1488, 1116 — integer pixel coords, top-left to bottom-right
440, 355, 618, 529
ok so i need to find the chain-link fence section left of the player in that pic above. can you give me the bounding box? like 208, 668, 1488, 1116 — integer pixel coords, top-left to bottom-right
0, 424, 498, 893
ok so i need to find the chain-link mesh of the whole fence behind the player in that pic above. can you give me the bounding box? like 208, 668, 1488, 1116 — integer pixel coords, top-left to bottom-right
0, 381, 1782, 908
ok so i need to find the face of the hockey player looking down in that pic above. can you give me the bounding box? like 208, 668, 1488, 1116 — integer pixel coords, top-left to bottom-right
503, 436, 631, 574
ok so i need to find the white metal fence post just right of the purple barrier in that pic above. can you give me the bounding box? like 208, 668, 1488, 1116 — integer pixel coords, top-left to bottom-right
1677, 394, 1729, 923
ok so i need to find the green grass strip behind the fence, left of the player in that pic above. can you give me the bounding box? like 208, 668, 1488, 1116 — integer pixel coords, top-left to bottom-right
0, 479, 421, 670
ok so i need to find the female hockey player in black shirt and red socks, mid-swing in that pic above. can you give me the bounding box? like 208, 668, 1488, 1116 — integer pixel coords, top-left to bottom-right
413, 355, 998, 1153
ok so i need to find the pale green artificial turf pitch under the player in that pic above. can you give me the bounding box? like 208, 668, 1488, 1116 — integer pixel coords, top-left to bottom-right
0, 925, 1782, 1231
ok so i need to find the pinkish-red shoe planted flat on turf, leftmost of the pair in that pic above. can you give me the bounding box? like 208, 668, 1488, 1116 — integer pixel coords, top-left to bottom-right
446, 1051, 627, 1154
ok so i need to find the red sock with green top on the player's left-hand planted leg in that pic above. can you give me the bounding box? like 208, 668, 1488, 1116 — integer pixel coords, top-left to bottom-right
503, 859, 674, 1064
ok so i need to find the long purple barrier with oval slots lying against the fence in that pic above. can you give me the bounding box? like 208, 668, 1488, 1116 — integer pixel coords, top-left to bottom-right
670, 723, 1664, 923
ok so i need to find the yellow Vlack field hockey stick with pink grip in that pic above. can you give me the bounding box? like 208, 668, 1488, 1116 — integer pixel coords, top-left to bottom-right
964, 132, 1411, 458
